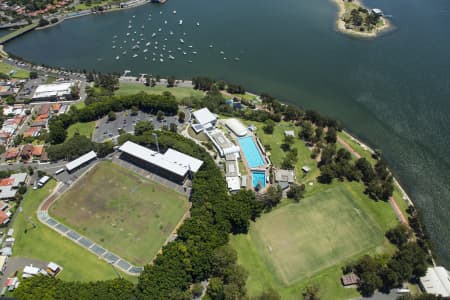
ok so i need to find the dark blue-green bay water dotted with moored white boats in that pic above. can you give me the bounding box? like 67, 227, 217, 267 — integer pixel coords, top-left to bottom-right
6, 0, 450, 268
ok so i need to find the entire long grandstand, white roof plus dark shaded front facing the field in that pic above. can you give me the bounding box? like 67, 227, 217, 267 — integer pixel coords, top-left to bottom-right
119, 141, 203, 184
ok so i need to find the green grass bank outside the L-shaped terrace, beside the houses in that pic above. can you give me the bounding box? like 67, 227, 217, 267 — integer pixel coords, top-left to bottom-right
14, 180, 136, 281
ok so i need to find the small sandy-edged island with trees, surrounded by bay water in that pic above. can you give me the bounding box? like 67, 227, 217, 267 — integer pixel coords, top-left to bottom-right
334, 0, 390, 37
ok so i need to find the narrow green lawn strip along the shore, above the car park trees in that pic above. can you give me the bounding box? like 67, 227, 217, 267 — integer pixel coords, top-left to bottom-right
115, 83, 204, 100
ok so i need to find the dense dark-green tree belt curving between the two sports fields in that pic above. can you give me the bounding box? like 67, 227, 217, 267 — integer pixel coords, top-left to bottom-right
16, 130, 263, 299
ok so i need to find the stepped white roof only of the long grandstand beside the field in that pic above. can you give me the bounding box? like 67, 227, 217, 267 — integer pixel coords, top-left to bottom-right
119, 141, 203, 176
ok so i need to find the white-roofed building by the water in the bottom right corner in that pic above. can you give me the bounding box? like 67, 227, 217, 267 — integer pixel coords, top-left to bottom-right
420, 267, 450, 297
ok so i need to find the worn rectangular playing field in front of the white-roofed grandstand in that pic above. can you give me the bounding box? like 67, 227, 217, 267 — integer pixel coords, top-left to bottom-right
50, 162, 188, 266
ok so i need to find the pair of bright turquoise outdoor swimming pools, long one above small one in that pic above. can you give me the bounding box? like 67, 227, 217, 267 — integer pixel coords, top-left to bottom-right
238, 136, 267, 188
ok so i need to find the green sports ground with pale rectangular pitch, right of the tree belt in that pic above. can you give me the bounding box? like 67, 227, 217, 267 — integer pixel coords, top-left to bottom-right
231, 183, 397, 299
